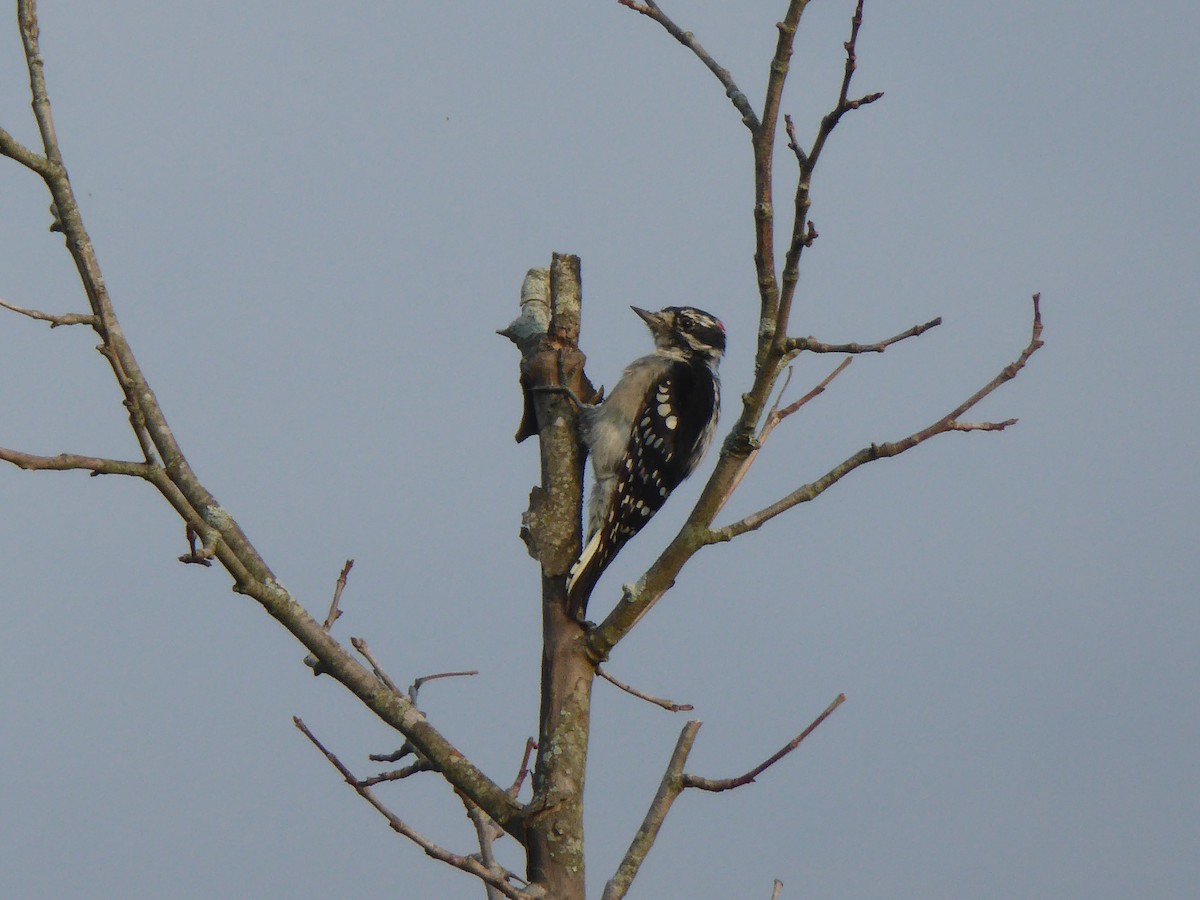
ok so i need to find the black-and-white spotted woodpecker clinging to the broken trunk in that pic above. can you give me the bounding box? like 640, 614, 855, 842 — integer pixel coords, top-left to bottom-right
566, 306, 725, 619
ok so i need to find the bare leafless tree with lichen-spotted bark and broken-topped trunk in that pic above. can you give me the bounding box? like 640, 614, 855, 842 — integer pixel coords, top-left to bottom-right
0, 0, 1042, 900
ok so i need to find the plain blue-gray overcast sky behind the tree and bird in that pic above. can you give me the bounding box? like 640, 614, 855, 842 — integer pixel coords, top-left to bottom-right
0, 0, 1200, 899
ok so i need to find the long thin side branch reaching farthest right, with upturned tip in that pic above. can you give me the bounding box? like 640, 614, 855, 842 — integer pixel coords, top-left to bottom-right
703, 294, 1043, 544
